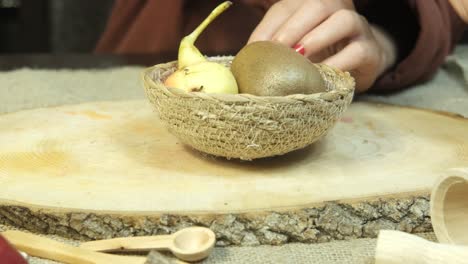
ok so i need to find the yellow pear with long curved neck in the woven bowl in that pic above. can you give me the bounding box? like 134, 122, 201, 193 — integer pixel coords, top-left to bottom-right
164, 1, 239, 94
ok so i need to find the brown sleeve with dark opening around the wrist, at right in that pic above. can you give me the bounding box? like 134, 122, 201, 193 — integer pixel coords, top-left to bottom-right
355, 0, 466, 92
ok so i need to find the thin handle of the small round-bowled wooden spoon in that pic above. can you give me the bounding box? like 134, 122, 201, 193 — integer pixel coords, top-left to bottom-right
80, 235, 173, 252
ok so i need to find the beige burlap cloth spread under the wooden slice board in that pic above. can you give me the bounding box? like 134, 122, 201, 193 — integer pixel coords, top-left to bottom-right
0, 46, 468, 263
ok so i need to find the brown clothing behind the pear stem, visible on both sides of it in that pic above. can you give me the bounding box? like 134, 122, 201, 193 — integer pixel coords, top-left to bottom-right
95, 0, 263, 55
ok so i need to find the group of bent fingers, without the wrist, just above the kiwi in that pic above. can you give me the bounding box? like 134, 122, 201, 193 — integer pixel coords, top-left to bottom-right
248, 0, 359, 50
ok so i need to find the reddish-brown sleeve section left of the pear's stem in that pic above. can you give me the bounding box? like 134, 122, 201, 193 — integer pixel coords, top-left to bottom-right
95, 0, 183, 54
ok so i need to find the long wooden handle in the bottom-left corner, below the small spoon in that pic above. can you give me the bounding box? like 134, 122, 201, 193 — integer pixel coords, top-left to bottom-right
0, 230, 146, 264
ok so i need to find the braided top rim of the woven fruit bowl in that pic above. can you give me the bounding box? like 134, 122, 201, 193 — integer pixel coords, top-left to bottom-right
141, 56, 355, 103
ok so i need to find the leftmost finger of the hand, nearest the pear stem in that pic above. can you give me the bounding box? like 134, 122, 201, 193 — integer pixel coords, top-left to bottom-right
248, 0, 300, 43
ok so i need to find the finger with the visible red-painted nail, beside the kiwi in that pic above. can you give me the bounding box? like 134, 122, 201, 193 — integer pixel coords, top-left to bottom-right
299, 9, 365, 57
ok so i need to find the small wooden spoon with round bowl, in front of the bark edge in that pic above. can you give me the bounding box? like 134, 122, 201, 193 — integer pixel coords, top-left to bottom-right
80, 227, 216, 261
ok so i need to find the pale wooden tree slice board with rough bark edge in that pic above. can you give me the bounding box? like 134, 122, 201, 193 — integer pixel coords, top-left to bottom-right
0, 101, 468, 245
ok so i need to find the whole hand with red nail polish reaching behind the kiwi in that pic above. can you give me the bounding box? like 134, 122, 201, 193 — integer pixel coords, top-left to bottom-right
249, 0, 396, 92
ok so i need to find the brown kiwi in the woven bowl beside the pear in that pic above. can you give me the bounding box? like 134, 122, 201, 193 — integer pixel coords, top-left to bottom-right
231, 41, 326, 96
